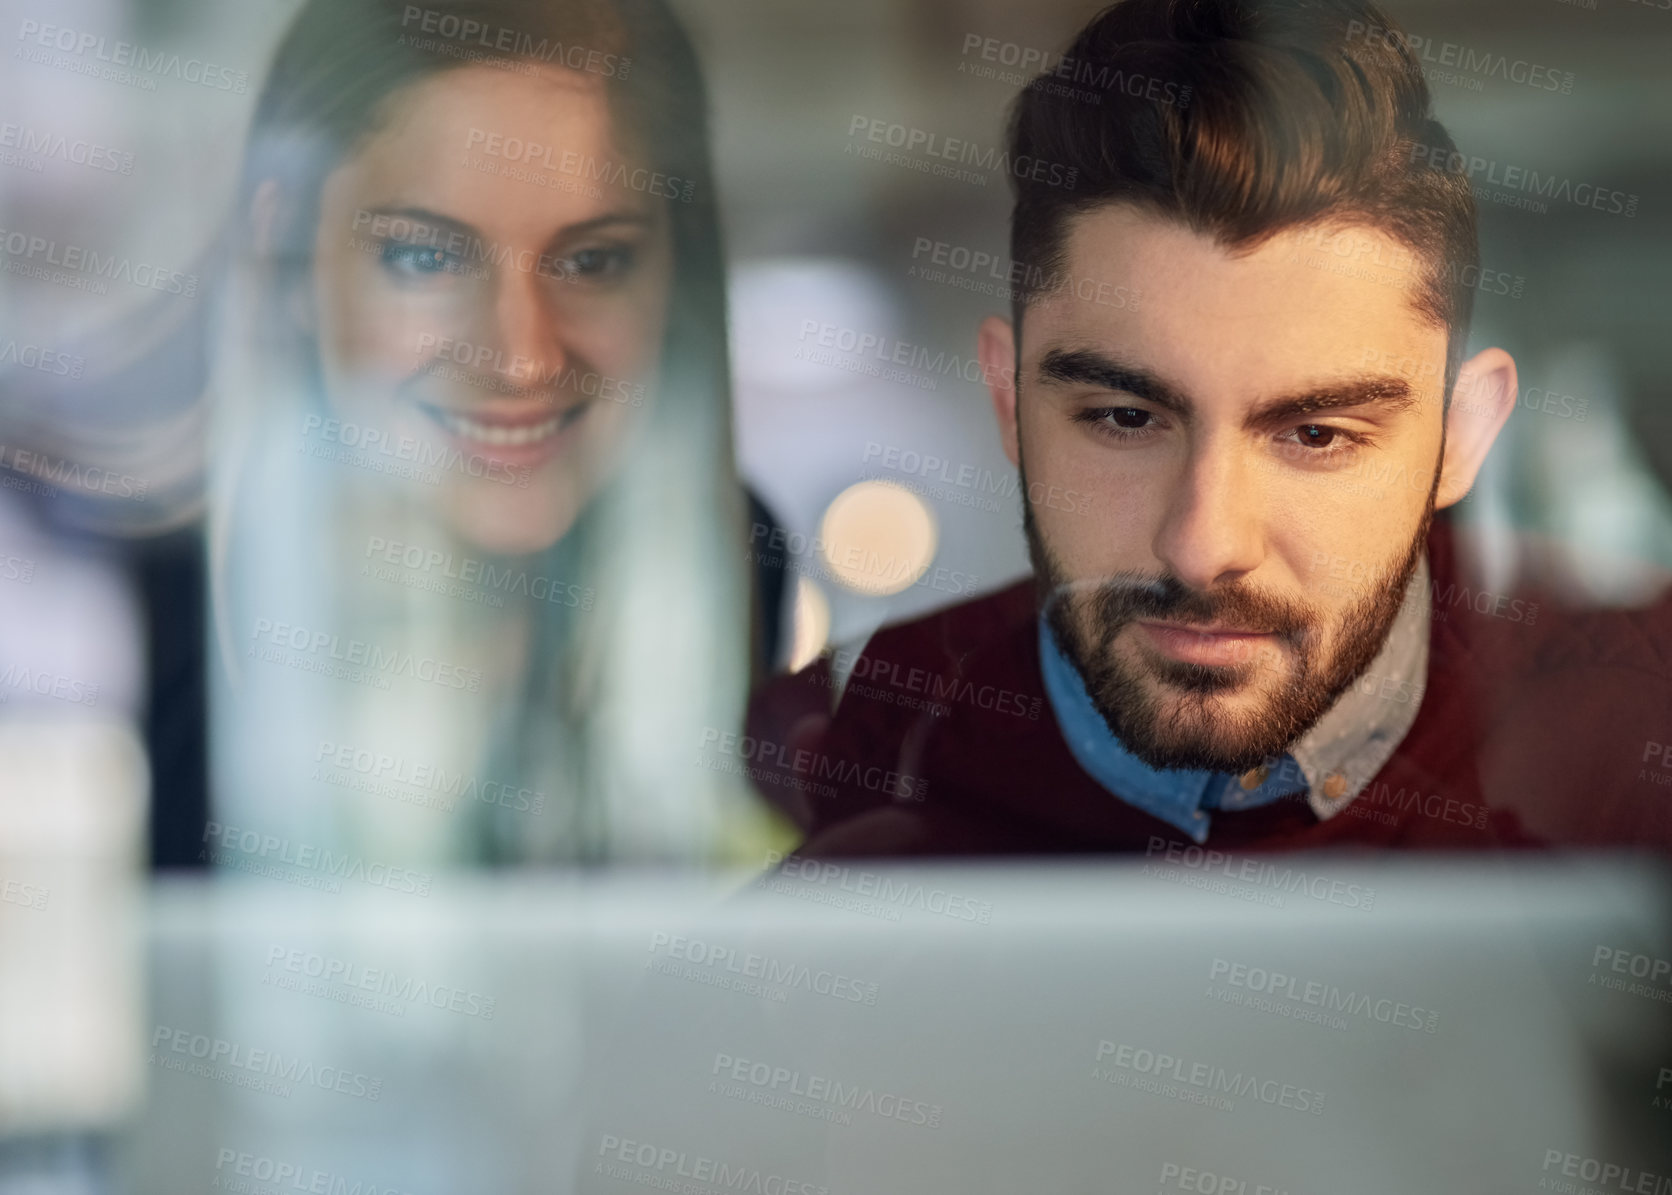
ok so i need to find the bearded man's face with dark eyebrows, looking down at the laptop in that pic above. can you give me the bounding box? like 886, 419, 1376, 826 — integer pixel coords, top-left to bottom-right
1002, 206, 1466, 772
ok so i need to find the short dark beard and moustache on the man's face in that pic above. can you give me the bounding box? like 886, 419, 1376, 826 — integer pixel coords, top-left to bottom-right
1022, 457, 1440, 772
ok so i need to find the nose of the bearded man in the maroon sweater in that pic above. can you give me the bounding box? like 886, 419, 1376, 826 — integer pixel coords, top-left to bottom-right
1152, 436, 1266, 590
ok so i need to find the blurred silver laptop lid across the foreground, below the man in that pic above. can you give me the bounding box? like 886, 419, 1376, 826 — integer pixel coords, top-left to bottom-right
29, 849, 1672, 1195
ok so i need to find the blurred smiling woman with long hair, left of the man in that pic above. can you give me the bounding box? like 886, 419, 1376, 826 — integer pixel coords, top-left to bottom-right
206, 0, 772, 874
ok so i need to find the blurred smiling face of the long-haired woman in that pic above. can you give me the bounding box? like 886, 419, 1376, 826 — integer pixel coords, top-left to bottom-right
304, 62, 679, 553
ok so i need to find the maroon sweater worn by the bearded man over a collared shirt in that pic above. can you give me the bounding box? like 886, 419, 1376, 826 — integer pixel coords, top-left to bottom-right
739, 518, 1672, 857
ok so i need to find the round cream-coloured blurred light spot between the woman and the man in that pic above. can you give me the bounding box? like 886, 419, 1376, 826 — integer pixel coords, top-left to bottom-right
819, 481, 936, 595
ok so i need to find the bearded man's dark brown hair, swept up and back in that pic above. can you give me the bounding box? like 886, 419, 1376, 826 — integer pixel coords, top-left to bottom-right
1007, 0, 1480, 399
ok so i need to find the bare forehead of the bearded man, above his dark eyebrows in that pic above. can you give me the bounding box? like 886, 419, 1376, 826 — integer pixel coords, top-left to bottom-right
1023, 204, 1446, 394
